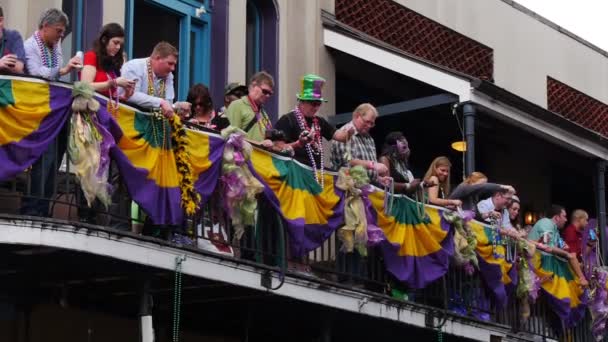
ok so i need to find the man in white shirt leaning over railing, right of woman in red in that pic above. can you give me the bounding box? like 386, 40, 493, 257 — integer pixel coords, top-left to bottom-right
120, 42, 190, 118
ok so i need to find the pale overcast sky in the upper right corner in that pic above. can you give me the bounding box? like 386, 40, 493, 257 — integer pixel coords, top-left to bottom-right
515, 0, 608, 51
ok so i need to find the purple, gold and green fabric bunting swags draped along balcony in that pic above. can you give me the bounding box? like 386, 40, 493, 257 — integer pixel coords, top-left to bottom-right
0, 77, 583, 332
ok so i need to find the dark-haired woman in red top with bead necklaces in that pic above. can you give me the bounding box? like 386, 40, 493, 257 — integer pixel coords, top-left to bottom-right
80, 23, 135, 111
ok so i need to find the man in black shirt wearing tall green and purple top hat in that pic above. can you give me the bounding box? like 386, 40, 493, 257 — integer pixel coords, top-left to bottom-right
276, 74, 354, 170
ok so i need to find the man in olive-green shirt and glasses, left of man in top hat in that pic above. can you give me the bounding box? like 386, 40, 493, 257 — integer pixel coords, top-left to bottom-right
226, 71, 274, 146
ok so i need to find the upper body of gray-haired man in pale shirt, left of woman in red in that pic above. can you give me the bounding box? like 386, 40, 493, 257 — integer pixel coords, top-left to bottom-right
24, 8, 82, 81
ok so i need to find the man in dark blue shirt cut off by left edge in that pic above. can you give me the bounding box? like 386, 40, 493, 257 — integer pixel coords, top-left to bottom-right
0, 7, 25, 74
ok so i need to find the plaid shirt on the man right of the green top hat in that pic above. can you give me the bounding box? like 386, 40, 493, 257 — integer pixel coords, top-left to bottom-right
331, 121, 378, 180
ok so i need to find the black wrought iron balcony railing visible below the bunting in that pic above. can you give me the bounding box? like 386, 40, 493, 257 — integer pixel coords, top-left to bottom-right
0, 134, 592, 341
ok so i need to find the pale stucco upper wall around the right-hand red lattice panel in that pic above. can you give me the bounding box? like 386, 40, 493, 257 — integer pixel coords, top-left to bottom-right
395, 0, 608, 108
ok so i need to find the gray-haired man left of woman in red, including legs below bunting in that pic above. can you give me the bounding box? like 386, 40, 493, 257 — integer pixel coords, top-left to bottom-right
20, 8, 82, 216
